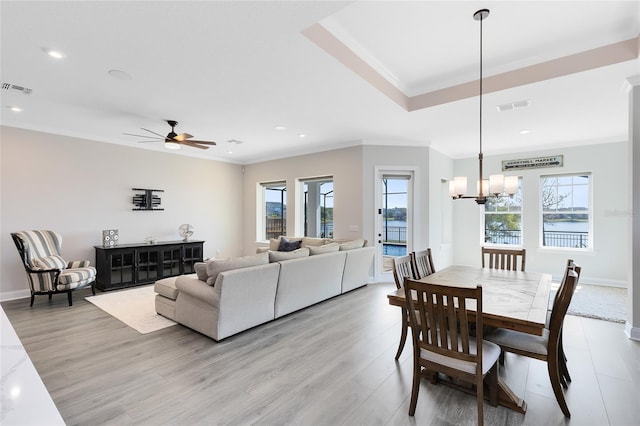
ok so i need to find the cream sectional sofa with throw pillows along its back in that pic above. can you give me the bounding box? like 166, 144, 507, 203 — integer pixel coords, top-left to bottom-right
155, 239, 375, 341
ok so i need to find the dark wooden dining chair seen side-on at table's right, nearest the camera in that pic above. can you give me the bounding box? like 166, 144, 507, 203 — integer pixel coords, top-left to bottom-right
486, 266, 578, 417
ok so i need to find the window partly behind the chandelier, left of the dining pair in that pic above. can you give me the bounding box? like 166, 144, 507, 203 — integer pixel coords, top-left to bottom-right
483, 178, 522, 245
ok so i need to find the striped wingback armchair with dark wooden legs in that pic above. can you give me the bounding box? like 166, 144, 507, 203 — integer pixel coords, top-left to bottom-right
11, 231, 96, 306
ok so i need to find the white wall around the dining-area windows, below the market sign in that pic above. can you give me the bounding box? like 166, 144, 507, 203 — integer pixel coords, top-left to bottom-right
453, 142, 630, 287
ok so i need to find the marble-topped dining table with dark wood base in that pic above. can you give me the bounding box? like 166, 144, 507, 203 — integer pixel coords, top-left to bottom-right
387, 265, 551, 414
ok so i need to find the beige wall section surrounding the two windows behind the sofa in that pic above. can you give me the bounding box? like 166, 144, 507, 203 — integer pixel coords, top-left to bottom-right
244, 146, 367, 255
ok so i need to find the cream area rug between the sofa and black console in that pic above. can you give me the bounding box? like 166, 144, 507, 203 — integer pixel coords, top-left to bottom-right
85, 285, 176, 334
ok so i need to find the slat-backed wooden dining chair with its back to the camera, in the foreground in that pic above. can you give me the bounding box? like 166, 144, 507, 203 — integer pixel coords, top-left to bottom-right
404, 278, 500, 425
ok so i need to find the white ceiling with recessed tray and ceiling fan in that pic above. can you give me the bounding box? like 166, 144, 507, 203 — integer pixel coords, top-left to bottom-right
0, 0, 640, 164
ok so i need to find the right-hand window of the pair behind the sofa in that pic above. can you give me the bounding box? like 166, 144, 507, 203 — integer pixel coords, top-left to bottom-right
300, 176, 333, 238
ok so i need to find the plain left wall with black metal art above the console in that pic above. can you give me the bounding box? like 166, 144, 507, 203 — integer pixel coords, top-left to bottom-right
0, 127, 243, 300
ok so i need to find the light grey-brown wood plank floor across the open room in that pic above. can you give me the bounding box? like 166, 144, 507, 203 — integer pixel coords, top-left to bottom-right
2, 283, 640, 425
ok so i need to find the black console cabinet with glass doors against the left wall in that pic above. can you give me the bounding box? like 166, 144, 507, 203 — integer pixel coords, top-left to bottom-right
94, 241, 204, 290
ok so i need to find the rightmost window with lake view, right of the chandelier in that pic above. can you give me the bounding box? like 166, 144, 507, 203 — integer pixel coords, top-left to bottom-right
540, 173, 591, 249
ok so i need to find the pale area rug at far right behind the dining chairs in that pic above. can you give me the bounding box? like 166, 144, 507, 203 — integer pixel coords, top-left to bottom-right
550, 283, 627, 323
